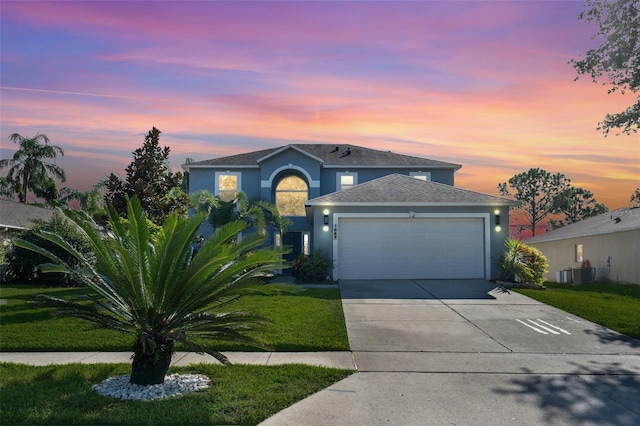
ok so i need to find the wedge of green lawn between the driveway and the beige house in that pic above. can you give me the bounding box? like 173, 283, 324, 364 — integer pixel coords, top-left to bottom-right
514, 283, 640, 339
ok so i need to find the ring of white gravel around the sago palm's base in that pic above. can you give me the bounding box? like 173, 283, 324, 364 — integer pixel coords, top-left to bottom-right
91, 374, 211, 401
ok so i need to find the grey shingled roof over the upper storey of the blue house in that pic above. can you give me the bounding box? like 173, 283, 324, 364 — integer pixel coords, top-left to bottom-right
183, 144, 462, 170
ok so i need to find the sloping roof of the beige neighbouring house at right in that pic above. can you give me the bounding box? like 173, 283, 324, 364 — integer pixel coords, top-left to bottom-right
527, 207, 640, 243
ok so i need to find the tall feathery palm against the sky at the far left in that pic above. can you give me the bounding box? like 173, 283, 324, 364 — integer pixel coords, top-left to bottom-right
0, 133, 67, 203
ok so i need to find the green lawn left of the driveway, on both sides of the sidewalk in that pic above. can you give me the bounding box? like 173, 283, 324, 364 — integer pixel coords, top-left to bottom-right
0, 285, 353, 425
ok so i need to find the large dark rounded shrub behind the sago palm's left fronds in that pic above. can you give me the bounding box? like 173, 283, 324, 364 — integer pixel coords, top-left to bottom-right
6, 212, 94, 286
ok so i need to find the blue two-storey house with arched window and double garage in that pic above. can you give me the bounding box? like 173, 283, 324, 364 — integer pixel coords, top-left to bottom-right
183, 144, 516, 279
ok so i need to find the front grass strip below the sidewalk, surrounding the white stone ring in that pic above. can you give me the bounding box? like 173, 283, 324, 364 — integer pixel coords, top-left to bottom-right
0, 363, 353, 425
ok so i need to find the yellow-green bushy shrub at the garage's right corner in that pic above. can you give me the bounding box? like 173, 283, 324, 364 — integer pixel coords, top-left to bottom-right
498, 238, 549, 285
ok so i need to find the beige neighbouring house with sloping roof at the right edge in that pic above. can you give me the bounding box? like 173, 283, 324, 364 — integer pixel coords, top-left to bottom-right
526, 208, 640, 284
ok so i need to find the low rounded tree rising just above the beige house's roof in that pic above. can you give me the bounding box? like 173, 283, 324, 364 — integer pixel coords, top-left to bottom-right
549, 186, 609, 229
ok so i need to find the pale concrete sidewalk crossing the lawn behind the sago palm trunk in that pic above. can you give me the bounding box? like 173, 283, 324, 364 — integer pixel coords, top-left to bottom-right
0, 352, 356, 370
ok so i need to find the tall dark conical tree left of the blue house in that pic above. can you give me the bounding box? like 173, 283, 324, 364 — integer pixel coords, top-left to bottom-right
104, 127, 187, 224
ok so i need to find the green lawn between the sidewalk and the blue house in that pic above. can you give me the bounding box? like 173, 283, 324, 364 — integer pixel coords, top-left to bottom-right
0, 285, 349, 352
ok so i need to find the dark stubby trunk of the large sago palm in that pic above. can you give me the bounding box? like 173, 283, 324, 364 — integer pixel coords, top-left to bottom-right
129, 339, 174, 386
